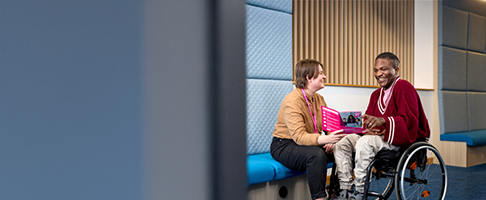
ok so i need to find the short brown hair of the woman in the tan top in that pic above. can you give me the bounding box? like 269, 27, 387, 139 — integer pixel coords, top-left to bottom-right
295, 59, 324, 89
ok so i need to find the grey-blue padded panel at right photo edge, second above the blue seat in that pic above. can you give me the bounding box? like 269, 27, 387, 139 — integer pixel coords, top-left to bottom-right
467, 52, 486, 91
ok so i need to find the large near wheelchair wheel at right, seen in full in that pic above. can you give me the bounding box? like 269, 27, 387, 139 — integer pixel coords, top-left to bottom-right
395, 142, 447, 200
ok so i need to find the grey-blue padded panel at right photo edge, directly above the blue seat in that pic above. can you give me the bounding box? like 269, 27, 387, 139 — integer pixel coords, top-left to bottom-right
467, 92, 486, 131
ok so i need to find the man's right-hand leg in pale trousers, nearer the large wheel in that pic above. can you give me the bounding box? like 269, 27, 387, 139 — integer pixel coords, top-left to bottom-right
354, 135, 398, 193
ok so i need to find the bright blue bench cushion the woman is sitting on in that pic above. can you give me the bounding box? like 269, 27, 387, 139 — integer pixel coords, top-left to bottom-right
246, 153, 333, 185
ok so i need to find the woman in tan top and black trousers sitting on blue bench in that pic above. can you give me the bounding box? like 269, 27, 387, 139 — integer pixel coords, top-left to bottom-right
270, 59, 344, 200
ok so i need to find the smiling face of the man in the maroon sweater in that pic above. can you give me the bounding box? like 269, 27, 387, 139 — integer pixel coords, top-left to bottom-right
374, 58, 398, 89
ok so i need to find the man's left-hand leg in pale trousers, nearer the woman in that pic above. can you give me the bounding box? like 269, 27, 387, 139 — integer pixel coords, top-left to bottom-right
334, 134, 361, 190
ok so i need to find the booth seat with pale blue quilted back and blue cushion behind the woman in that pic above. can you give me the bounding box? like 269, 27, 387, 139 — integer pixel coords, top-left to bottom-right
246, 0, 332, 200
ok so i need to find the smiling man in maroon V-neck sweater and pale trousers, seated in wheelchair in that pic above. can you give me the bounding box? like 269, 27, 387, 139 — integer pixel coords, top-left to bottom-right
334, 52, 430, 200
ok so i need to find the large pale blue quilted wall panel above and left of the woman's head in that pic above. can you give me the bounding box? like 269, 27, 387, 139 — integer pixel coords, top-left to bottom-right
246, 5, 292, 80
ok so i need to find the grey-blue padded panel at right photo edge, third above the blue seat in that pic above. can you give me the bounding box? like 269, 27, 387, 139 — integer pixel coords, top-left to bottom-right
467, 13, 486, 53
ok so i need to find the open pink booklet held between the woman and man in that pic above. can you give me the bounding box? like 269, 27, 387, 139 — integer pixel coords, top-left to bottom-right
321, 106, 362, 133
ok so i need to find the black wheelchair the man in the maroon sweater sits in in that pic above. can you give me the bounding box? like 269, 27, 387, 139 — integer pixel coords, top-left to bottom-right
329, 141, 447, 200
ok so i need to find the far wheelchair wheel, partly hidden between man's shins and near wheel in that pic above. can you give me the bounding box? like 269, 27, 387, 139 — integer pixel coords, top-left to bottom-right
365, 161, 395, 200
